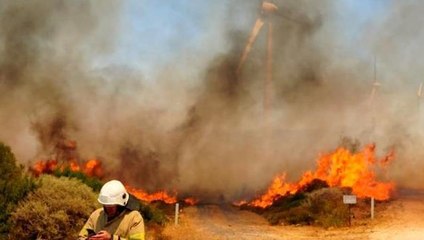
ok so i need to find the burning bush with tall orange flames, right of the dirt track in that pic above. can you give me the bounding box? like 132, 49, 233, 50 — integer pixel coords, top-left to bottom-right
237, 142, 395, 227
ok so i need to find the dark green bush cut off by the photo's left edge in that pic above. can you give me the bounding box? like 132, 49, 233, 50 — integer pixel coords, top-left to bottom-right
0, 143, 36, 239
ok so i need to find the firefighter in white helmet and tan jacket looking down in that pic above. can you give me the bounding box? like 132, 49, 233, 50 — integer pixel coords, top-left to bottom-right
78, 180, 144, 240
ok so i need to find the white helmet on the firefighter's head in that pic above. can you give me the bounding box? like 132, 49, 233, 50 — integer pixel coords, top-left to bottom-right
97, 180, 129, 206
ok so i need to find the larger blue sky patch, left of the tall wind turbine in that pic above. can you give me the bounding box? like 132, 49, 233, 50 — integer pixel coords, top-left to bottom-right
93, 0, 232, 78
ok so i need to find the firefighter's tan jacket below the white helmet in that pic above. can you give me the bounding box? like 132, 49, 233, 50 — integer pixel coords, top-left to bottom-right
78, 208, 144, 240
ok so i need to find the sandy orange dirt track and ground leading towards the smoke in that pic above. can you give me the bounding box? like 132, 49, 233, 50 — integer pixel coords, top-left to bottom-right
162, 190, 424, 240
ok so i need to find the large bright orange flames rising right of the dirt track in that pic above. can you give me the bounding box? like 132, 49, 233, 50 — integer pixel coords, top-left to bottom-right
248, 144, 394, 208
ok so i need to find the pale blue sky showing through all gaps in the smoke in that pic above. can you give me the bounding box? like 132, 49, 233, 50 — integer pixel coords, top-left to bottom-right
96, 0, 391, 79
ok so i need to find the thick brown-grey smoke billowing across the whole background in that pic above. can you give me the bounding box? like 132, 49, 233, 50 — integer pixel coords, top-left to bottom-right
0, 0, 424, 200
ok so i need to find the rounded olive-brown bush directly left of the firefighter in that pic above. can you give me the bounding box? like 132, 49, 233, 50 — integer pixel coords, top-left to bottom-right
10, 175, 99, 240
